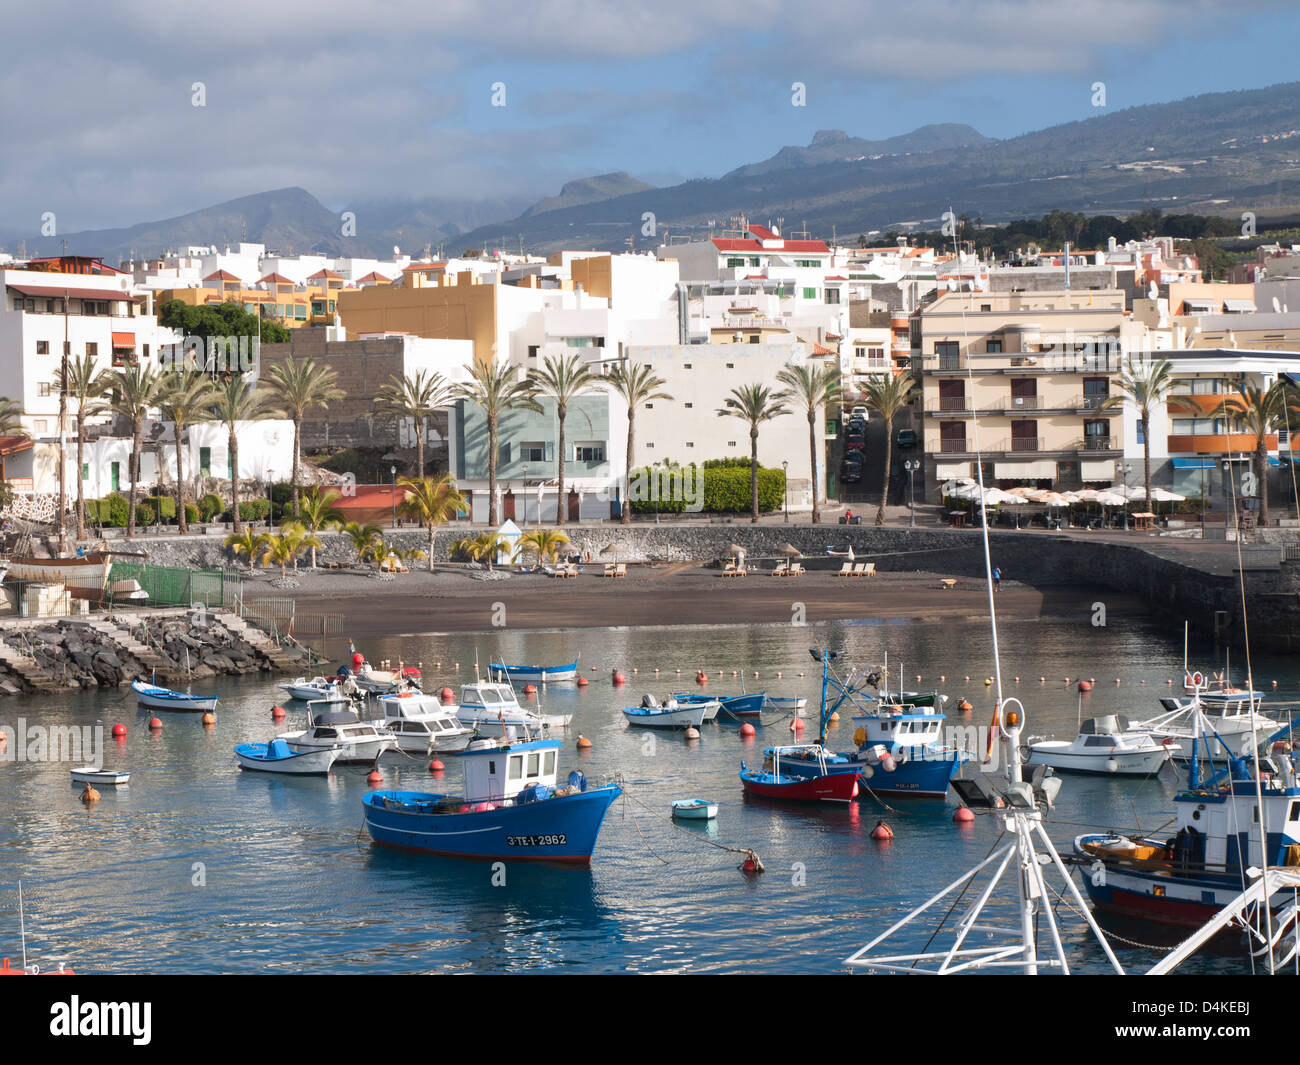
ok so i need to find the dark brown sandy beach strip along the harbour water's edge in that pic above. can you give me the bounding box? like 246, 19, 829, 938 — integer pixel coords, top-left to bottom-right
244, 563, 1148, 637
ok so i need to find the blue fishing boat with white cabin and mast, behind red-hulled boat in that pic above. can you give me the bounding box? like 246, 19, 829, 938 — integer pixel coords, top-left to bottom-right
774, 650, 972, 798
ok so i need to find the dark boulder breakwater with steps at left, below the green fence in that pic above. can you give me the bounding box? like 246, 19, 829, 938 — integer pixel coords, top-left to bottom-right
0, 611, 307, 694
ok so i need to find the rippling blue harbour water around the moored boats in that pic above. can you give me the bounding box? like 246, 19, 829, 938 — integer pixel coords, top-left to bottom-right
0, 614, 1300, 973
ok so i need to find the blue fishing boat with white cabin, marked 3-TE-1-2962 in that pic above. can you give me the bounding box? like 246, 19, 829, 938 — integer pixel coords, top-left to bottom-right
361, 740, 623, 865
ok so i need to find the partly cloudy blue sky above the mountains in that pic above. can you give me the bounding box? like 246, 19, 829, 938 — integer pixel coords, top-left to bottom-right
0, 0, 1300, 233
